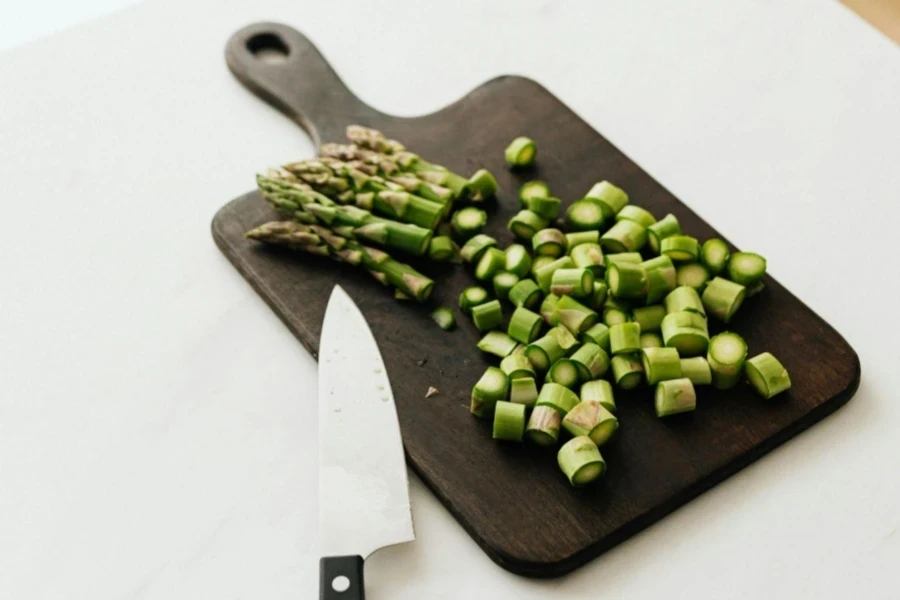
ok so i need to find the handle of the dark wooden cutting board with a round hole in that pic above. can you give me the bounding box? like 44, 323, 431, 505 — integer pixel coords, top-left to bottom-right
225, 23, 379, 148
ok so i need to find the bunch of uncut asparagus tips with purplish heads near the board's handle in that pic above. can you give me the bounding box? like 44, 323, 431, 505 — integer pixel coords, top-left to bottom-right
247, 125, 497, 302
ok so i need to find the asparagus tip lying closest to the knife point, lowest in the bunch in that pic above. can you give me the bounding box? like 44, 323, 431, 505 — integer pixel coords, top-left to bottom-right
246, 221, 434, 302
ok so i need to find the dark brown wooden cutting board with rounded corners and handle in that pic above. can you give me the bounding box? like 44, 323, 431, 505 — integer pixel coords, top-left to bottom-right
212, 23, 860, 577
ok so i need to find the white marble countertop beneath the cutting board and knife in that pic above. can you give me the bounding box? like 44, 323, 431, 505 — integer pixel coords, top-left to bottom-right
0, 0, 900, 600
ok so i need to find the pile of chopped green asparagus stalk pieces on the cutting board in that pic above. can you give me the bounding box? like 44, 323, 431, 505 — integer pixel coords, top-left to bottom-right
459, 138, 791, 485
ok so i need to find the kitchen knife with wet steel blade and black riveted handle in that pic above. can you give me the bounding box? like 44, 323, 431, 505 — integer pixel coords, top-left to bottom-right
319, 285, 415, 600
